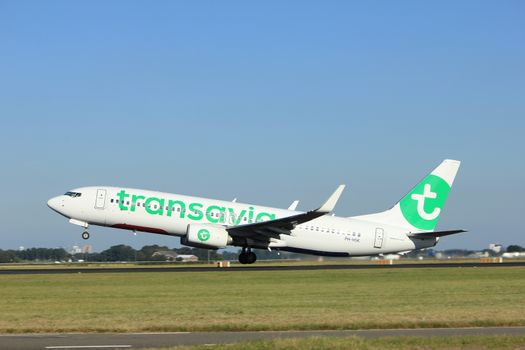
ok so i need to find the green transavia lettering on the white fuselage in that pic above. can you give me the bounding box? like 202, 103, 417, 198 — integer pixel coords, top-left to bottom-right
117, 190, 275, 225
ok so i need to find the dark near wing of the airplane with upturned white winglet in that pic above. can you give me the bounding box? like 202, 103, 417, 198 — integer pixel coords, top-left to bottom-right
226, 185, 345, 240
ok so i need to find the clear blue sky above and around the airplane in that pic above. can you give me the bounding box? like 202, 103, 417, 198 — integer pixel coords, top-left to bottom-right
0, 1, 525, 250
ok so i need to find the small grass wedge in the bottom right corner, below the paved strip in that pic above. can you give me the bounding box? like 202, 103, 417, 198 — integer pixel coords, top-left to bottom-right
141, 336, 525, 350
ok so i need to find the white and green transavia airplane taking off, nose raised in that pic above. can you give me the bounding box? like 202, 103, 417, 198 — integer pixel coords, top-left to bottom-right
47, 159, 466, 264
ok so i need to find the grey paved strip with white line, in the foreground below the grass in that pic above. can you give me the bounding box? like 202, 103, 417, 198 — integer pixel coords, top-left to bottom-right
0, 327, 525, 350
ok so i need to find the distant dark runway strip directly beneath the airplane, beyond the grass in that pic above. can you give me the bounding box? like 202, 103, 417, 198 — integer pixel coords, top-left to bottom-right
0, 261, 525, 275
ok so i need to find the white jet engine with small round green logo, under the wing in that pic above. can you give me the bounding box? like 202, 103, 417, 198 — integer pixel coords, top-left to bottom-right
180, 224, 233, 249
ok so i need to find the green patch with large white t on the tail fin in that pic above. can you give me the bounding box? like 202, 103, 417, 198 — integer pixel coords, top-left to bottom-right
399, 174, 450, 230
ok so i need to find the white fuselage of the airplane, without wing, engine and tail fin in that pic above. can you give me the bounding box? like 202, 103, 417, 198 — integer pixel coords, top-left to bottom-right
48, 186, 437, 256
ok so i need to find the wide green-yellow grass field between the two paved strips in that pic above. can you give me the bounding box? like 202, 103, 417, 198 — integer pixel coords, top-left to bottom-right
0, 267, 525, 333
